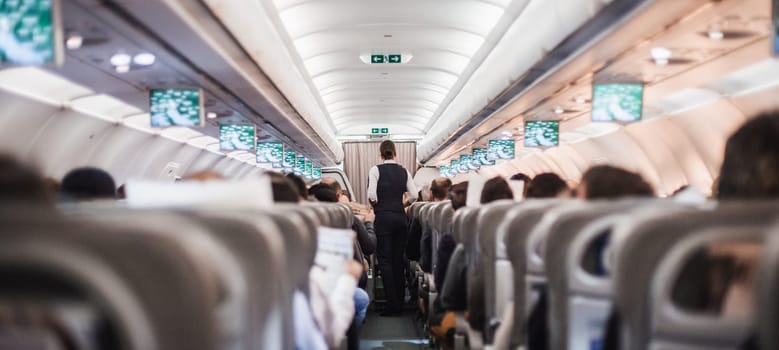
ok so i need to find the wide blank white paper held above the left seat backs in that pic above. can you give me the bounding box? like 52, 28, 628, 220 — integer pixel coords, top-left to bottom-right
125, 176, 273, 209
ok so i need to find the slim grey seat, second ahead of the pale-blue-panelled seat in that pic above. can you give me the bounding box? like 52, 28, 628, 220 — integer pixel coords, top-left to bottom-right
468, 200, 523, 344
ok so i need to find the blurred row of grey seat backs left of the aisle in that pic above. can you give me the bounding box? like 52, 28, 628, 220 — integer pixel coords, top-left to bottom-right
0, 203, 352, 350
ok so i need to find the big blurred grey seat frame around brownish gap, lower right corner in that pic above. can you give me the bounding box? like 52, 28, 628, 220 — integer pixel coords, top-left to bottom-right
649, 224, 766, 350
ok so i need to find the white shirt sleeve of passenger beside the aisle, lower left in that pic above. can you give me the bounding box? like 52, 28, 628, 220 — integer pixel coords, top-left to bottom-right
308, 264, 357, 348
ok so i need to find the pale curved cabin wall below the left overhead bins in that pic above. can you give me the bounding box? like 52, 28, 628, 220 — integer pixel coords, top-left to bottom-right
0, 73, 262, 184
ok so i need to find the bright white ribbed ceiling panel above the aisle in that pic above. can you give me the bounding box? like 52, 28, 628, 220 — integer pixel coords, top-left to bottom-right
274, 0, 511, 135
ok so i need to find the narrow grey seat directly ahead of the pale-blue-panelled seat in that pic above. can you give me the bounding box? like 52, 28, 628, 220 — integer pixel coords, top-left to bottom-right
504, 201, 560, 348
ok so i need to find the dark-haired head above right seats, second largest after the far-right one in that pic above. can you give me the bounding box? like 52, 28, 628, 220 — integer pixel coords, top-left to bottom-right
576, 165, 654, 199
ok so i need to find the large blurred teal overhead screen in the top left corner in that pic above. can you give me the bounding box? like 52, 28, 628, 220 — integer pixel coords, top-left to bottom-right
0, 0, 63, 65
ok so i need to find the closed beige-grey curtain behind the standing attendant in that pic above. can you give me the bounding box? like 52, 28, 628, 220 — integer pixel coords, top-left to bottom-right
344, 141, 417, 204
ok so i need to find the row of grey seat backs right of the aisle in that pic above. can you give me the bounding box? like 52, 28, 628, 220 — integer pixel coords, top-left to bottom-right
409, 199, 779, 349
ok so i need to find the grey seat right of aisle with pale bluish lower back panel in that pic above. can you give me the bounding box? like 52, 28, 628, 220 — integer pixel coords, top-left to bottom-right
541, 199, 671, 349
